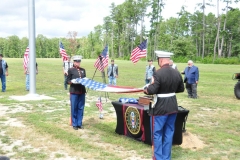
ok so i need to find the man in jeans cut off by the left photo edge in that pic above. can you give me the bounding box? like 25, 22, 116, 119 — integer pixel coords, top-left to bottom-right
0, 54, 8, 92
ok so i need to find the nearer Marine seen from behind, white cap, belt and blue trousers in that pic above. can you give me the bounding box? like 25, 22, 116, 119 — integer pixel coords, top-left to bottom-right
144, 51, 184, 160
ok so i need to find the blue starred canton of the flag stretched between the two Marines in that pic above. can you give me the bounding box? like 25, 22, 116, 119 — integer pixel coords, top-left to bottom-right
76, 78, 107, 90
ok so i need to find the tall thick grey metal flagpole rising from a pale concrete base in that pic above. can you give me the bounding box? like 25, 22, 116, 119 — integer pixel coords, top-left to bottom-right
28, 0, 37, 96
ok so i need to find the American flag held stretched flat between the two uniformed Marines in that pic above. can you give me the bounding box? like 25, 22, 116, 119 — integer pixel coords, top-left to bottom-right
71, 78, 143, 93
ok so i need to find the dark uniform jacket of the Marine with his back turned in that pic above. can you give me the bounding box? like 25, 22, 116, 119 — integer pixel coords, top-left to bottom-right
147, 64, 184, 115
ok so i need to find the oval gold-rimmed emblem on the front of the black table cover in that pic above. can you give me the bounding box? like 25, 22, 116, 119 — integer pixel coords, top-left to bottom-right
125, 107, 141, 135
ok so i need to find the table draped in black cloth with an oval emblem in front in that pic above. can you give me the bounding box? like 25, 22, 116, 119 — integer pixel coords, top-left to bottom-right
112, 101, 189, 145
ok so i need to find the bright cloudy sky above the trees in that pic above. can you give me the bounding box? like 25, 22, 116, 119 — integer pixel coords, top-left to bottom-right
0, 0, 240, 38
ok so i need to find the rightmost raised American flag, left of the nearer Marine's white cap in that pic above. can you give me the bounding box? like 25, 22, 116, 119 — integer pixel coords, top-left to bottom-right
130, 40, 147, 64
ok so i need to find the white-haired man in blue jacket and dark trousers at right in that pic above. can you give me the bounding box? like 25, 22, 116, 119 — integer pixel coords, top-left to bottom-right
182, 60, 199, 99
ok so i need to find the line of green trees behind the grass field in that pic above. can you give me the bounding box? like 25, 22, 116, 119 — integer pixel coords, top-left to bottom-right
0, 0, 240, 63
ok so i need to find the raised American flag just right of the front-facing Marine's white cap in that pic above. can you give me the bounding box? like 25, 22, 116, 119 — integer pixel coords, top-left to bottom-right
94, 45, 108, 72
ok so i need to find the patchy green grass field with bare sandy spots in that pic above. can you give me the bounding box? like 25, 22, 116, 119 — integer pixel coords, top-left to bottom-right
0, 59, 240, 160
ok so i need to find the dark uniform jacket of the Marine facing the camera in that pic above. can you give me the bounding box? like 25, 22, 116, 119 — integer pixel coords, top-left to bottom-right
67, 67, 86, 94
